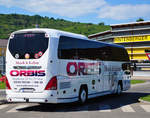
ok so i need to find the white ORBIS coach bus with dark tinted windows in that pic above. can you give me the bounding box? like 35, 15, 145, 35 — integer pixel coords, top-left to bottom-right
6, 28, 130, 103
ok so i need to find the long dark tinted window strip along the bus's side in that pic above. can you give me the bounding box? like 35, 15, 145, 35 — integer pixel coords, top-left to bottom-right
58, 36, 129, 61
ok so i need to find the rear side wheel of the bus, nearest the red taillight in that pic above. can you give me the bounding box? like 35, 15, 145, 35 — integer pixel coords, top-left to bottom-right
79, 87, 88, 104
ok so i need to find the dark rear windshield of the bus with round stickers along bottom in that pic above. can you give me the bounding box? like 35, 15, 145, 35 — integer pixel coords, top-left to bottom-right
8, 33, 48, 59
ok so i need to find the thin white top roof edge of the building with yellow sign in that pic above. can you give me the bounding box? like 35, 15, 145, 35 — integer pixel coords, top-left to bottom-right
110, 21, 150, 27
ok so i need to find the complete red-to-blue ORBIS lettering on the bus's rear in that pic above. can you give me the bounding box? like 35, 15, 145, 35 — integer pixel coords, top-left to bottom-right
10, 70, 46, 76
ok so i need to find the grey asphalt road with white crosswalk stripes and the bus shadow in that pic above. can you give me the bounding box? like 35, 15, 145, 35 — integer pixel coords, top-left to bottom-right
0, 82, 150, 118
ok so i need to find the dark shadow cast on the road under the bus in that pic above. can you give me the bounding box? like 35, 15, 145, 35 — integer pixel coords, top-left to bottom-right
19, 92, 150, 112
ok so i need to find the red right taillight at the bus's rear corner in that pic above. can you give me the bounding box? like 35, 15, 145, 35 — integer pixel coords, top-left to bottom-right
45, 76, 57, 90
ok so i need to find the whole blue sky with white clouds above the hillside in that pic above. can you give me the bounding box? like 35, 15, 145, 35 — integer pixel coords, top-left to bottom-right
0, 0, 150, 25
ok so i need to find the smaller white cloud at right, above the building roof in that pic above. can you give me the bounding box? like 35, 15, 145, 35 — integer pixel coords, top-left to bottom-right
99, 4, 150, 20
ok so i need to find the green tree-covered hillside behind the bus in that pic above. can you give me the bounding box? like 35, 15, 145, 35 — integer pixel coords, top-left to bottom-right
0, 14, 110, 39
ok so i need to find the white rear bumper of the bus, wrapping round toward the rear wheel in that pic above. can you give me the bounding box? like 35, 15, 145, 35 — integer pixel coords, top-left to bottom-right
6, 91, 78, 103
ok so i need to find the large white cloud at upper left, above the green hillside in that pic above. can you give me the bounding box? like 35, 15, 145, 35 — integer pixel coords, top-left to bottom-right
0, 0, 106, 17
